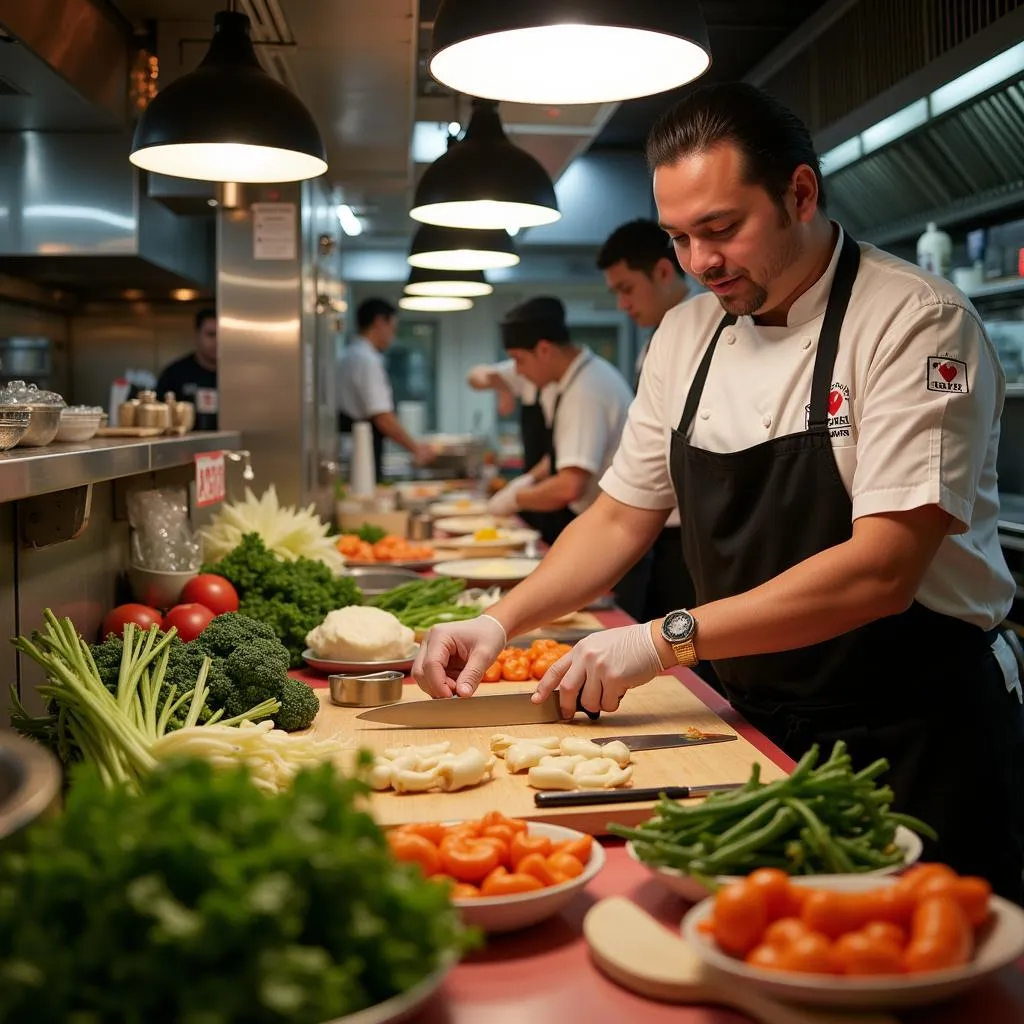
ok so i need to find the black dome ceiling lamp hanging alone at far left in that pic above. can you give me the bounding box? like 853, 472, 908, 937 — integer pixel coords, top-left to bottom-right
129, 10, 327, 182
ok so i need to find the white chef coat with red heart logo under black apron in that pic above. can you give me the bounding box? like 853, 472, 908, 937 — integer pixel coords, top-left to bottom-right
601, 224, 1015, 630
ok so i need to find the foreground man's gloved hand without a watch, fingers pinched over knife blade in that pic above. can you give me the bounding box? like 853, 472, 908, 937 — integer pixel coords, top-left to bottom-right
413, 615, 508, 697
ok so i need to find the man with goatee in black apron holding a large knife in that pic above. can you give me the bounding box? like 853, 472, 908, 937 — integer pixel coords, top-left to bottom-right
414, 83, 1024, 901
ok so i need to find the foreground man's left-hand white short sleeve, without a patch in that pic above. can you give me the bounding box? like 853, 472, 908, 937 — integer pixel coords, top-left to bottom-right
601, 321, 678, 509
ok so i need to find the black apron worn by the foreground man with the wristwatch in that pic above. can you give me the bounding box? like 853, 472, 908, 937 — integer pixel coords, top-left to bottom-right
671, 236, 1024, 902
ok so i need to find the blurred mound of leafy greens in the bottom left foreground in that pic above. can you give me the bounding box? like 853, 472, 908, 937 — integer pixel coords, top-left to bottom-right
0, 762, 475, 1024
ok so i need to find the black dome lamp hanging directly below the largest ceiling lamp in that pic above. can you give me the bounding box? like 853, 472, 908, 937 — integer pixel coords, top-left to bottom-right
410, 99, 561, 228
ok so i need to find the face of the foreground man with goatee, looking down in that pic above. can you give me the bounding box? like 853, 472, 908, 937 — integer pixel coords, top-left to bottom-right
654, 142, 818, 316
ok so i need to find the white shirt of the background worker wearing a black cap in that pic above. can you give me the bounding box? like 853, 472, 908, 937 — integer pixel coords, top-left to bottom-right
554, 347, 633, 515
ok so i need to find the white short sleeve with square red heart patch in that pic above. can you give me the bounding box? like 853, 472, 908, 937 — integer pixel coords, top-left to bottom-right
851, 300, 1004, 534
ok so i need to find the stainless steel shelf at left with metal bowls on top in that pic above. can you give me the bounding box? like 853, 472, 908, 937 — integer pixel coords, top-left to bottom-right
0, 430, 242, 502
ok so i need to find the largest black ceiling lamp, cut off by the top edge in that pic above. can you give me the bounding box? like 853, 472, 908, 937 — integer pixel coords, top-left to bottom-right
429, 0, 711, 104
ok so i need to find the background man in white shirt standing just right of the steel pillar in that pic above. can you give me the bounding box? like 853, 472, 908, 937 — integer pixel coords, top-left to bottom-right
335, 299, 434, 477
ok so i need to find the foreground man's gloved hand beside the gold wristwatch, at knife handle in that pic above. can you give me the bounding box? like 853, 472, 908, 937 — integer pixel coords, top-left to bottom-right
534, 623, 663, 718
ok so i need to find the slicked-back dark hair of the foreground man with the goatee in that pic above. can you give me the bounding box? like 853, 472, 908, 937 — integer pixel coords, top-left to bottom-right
647, 82, 825, 210
